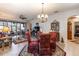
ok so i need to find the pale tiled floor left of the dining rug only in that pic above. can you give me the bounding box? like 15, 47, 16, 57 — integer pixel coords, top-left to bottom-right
0, 42, 27, 56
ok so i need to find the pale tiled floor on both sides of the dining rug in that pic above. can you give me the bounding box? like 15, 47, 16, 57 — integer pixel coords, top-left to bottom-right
0, 41, 79, 56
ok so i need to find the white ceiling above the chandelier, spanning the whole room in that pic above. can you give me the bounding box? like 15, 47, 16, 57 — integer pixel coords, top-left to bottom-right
0, 3, 79, 19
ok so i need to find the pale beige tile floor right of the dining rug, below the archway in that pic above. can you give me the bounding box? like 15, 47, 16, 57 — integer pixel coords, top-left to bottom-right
61, 41, 79, 56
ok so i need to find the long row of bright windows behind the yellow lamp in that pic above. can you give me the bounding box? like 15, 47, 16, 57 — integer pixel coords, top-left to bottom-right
0, 21, 25, 33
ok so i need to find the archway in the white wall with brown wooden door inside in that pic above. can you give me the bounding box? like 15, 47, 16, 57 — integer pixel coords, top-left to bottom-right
67, 16, 79, 40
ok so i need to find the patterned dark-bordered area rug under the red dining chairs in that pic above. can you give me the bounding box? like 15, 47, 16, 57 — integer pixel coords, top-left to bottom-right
19, 45, 66, 56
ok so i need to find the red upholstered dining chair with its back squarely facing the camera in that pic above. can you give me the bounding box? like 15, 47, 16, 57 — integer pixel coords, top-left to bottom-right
39, 33, 52, 56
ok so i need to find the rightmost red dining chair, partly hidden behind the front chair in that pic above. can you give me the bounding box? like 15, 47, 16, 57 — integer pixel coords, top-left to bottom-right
50, 32, 57, 51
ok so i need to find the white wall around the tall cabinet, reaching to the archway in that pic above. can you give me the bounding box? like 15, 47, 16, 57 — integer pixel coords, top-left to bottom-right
31, 9, 79, 41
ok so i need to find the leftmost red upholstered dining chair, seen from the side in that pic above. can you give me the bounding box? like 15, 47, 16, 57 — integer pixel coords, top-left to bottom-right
26, 32, 39, 55
